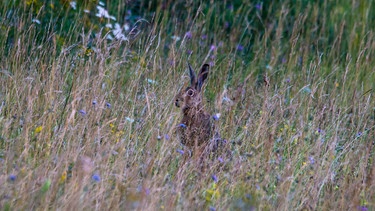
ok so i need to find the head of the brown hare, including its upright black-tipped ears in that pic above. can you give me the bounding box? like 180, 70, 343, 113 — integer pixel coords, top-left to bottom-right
175, 64, 210, 109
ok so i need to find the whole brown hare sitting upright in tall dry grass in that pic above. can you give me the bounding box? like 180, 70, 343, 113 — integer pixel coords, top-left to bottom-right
175, 64, 216, 152
